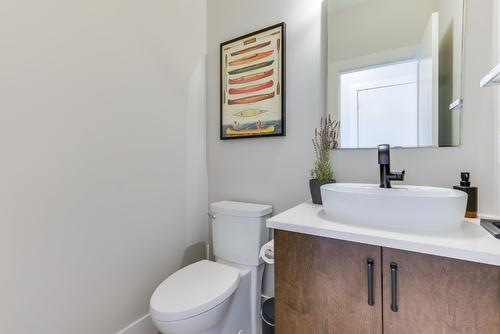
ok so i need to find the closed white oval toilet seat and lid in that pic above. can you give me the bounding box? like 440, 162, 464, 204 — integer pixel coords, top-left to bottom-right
150, 260, 240, 321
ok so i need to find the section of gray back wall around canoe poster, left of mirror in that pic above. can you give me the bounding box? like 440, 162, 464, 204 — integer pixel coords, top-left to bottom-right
207, 0, 326, 212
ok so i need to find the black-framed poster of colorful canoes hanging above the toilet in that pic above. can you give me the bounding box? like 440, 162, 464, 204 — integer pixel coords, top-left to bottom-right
220, 23, 286, 139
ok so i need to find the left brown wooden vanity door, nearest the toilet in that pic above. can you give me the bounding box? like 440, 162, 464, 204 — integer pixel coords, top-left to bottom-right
274, 230, 382, 334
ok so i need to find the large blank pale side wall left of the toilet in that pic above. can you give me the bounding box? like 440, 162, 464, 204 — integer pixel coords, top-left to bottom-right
0, 0, 207, 334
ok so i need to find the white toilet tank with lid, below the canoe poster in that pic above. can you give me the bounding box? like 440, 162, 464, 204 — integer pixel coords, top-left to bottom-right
210, 201, 273, 266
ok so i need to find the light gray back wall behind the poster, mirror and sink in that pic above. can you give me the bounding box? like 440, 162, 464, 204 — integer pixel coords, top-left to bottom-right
207, 0, 497, 213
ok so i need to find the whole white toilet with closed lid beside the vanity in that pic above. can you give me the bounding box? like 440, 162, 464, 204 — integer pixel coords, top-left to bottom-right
150, 201, 272, 334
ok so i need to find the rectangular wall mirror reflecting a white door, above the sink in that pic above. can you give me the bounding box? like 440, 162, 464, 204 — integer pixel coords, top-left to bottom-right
327, 0, 465, 148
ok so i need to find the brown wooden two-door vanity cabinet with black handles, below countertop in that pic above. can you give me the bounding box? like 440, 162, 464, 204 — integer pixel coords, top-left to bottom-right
275, 230, 500, 334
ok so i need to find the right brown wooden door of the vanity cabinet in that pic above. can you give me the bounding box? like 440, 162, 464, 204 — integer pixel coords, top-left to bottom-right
382, 246, 500, 334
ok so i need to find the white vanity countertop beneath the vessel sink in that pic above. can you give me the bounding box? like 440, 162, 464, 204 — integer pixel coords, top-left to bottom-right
267, 202, 500, 266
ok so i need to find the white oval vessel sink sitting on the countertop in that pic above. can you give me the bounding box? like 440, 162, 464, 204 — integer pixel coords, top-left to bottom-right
321, 183, 467, 232
